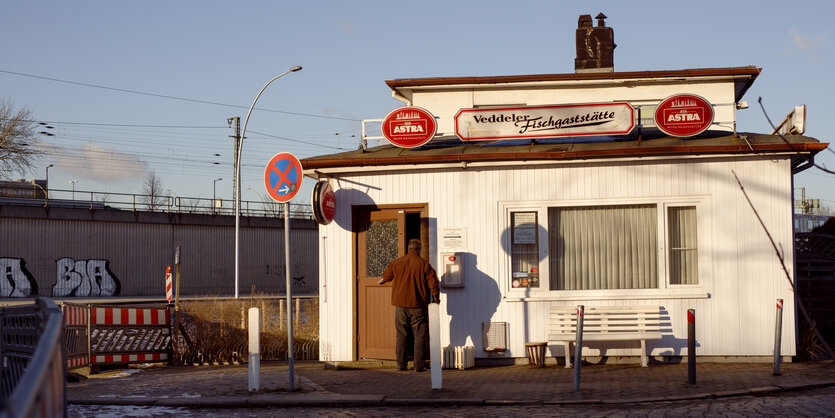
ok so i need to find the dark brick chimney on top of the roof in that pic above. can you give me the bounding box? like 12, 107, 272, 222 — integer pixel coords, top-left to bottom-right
574, 13, 617, 73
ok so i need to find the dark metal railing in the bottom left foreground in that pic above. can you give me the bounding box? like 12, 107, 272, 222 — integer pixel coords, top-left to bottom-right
0, 298, 66, 418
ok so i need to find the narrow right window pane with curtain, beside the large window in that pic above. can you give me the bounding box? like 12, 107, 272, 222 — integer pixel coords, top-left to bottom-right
667, 206, 699, 284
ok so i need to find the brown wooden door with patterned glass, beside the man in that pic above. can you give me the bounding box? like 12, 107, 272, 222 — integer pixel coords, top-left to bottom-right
354, 206, 429, 360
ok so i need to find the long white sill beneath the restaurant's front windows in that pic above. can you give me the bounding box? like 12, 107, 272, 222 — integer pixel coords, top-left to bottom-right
502, 287, 710, 302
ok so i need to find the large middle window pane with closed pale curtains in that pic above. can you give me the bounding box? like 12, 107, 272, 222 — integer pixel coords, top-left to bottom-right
548, 205, 658, 290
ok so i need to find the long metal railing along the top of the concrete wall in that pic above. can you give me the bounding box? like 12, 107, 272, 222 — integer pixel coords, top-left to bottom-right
0, 186, 313, 219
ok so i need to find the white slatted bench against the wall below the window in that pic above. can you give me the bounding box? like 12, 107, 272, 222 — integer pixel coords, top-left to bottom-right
548, 306, 661, 368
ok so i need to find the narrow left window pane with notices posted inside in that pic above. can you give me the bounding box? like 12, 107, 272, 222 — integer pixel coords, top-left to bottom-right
510, 212, 539, 287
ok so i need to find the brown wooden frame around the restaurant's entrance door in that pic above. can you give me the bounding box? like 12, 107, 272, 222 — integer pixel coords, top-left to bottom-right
351, 203, 432, 361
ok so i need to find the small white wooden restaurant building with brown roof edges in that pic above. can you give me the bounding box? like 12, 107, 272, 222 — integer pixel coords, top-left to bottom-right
302, 18, 827, 362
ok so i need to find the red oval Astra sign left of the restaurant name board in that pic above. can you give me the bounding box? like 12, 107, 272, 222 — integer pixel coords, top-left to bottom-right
382, 106, 438, 148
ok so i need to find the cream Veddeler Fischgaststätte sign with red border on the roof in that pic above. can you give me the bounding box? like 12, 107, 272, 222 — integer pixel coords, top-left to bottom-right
455, 102, 635, 141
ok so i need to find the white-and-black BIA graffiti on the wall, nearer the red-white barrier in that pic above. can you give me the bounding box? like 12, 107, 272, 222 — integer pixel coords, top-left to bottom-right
52, 257, 121, 297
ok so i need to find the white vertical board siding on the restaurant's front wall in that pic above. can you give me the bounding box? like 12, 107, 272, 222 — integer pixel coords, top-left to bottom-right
320, 157, 795, 361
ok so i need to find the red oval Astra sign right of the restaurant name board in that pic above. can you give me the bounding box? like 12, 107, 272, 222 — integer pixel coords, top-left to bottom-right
655, 94, 713, 138
